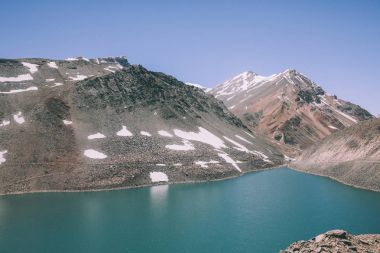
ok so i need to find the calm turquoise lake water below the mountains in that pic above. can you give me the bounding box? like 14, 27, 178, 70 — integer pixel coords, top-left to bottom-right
0, 168, 380, 253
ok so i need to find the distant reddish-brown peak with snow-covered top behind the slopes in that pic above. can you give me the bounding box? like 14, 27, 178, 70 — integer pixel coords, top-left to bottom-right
210, 70, 373, 156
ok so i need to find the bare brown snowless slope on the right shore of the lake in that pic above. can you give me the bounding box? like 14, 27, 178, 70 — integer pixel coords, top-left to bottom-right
290, 119, 380, 191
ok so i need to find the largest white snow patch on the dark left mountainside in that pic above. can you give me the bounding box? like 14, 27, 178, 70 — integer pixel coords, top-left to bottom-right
174, 127, 227, 149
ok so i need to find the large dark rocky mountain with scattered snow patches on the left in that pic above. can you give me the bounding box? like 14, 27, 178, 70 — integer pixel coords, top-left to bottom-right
0, 57, 283, 193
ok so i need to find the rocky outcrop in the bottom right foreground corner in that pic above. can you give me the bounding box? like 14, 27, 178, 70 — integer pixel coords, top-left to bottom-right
280, 230, 380, 253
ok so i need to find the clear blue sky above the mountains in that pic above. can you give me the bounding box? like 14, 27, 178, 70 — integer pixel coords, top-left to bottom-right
0, 0, 380, 115
